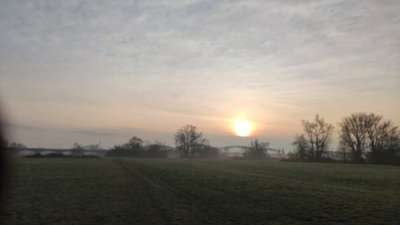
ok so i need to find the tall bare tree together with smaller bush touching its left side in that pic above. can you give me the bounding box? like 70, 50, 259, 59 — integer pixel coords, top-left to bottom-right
293, 115, 334, 161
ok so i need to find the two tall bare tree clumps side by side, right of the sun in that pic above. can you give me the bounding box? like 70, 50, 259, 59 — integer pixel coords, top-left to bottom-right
290, 113, 400, 164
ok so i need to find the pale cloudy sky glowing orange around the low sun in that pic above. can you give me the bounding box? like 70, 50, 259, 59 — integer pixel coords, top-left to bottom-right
0, 0, 400, 149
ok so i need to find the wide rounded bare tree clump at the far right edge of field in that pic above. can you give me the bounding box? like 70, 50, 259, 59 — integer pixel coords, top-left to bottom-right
340, 113, 400, 163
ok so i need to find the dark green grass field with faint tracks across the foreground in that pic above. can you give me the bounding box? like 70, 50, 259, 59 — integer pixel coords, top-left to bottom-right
2, 159, 400, 225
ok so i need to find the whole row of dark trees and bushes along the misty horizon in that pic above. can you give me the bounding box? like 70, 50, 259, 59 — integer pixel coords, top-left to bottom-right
7, 113, 400, 164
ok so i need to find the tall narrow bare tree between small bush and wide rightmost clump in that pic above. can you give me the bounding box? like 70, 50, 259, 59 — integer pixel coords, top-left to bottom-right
302, 115, 334, 161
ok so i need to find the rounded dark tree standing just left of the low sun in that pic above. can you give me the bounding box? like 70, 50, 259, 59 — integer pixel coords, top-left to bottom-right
175, 125, 208, 158
